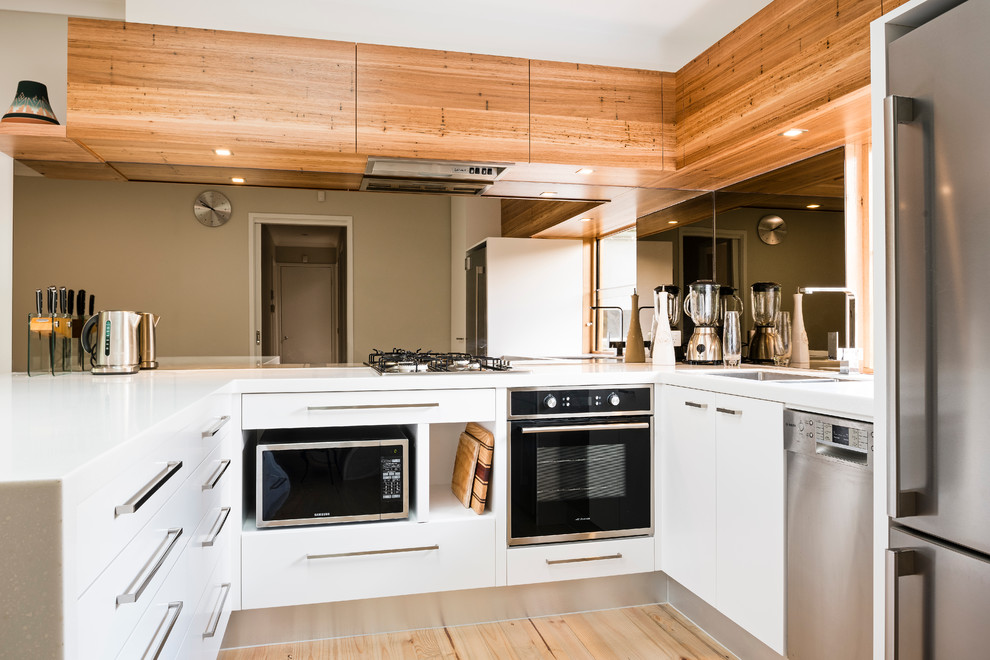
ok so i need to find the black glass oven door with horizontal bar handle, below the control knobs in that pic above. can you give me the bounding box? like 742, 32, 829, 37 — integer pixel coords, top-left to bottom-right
509, 417, 653, 545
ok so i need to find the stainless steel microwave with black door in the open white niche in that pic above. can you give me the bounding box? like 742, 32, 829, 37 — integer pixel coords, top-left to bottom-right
255, 426, 411, 527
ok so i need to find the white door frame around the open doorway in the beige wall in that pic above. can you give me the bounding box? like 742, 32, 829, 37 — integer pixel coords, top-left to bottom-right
248, 213, 354, 362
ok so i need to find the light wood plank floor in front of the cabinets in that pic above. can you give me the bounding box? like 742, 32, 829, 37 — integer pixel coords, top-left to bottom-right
218, 605, 735, 660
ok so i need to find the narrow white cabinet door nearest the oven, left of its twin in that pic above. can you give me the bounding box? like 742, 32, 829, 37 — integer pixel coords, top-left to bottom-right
655, 387, 716, 605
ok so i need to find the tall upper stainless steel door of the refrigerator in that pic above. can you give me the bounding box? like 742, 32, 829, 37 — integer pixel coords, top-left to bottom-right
887, 0, 990, 556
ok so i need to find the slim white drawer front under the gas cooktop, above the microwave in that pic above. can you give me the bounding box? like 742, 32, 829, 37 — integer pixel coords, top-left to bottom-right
241, 389, 495, 429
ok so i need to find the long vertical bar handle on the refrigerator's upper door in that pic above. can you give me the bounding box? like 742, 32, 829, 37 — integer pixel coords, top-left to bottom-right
883, 94, 923, 518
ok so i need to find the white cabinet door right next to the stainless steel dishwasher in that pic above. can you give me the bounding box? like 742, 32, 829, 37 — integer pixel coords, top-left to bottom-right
716, 394, 786, 654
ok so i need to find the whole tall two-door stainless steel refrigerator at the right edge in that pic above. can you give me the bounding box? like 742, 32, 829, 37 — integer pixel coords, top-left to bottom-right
884, 0, 990, 660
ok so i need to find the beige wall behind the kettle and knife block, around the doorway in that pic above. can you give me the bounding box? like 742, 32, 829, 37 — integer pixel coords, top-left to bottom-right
12, 176, 450, 371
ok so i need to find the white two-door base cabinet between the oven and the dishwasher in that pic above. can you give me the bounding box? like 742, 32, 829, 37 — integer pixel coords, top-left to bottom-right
657, 387, 786, 654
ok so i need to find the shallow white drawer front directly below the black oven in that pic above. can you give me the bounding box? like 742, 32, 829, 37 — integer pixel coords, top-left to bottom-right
506, 537, 654, 585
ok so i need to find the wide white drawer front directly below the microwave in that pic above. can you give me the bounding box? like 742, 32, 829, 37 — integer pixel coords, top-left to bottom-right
241, 516, 495, 609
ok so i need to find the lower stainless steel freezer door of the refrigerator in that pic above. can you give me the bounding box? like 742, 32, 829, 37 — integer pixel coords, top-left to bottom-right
887, 527, 990, 660
